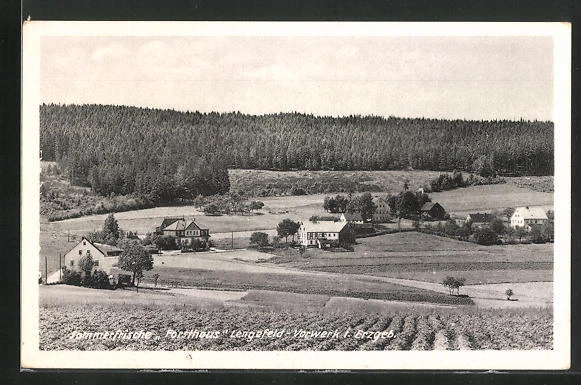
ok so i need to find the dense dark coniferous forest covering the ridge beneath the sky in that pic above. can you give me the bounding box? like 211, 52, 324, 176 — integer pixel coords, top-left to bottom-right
40, 104, 554, 203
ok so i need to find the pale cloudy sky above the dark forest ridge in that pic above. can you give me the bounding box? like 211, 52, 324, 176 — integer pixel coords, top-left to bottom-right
40, 36, 553, 120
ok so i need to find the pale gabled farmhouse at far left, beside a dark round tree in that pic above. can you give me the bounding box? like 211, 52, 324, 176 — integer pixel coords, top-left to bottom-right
64, 237, 123, 274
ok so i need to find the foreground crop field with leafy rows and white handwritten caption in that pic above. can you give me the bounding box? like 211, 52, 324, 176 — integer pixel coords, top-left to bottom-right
40, 305, 553, 351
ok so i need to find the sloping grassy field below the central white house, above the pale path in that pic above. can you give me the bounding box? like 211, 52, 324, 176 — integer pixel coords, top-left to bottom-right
268, 232, 553, 285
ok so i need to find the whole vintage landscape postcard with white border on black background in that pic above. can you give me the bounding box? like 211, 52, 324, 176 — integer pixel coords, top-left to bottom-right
21, 21, 571, 370
